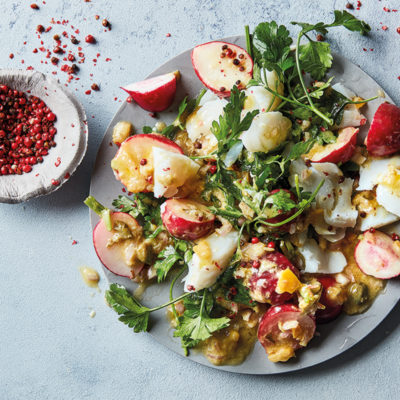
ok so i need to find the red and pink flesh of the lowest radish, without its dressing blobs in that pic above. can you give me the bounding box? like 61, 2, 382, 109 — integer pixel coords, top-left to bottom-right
257, 304, 315, 361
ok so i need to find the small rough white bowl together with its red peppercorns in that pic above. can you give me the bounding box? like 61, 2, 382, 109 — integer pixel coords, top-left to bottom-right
0, 70, 88, 203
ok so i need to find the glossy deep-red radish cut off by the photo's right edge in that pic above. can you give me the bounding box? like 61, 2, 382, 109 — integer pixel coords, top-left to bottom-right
365, 103, 400, 157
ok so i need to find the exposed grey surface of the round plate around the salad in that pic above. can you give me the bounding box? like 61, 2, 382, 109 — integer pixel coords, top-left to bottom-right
90, 36, 400, 375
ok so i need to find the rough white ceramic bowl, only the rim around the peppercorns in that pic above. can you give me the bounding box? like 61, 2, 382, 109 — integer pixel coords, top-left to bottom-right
0, 70, 88, 203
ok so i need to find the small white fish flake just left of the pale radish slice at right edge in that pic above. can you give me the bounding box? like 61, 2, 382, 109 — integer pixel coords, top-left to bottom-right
298, 239, 347, 274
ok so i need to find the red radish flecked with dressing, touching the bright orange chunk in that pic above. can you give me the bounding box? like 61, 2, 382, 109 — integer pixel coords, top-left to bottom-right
246, 251, 300, 305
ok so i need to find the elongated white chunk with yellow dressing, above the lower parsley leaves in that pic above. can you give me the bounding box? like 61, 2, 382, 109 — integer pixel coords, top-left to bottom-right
183, 231, 239, 292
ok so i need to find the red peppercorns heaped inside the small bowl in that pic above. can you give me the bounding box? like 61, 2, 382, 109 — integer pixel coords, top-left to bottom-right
0, 83, 57, 176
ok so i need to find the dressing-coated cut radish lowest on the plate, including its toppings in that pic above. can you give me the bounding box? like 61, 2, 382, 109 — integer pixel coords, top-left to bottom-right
258, 304, 315, 362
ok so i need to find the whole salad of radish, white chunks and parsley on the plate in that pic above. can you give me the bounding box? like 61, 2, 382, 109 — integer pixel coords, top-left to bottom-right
85, 11, 400, 365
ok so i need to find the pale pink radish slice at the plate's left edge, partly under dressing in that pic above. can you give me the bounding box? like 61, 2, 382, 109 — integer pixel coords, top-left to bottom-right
93, 212, 144, 278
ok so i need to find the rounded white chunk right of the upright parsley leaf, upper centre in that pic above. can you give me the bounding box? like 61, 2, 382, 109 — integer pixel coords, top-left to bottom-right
240, 111, 292, 153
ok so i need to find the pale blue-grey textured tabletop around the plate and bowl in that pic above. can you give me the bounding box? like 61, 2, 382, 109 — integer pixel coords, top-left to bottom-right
0, 0, 400, 400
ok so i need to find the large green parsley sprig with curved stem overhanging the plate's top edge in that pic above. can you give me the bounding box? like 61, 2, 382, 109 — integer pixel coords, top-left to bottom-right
245, 10, 376, 126
